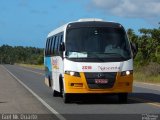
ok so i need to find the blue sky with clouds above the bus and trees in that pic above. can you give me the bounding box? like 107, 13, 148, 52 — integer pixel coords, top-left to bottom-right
0, 0, 160, 48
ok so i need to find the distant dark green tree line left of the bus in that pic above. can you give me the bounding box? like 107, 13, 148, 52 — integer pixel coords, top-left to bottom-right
0, 45, 43, 65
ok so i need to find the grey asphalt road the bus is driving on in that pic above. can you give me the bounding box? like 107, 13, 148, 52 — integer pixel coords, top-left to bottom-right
0, 65, 160, 120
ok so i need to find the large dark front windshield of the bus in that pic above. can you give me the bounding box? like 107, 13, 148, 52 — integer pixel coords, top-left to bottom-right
66, 27, 131, 61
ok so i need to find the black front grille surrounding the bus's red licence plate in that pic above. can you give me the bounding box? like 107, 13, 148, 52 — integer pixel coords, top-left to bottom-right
85, 72, 117, 89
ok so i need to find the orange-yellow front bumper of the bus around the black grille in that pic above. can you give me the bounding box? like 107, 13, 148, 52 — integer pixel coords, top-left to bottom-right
64, 73, 133, 94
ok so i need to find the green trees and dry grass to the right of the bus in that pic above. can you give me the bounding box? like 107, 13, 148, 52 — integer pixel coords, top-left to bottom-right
127, 25, 160, 83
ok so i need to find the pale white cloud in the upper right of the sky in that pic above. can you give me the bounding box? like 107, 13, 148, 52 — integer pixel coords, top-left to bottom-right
91, 0, 160, 18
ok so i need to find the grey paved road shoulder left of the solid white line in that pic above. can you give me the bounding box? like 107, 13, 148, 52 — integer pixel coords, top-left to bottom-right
0, 65, 50, 114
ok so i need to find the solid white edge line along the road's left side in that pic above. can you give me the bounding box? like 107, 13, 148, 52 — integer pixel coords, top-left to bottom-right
2, 66, 66, 120
